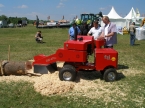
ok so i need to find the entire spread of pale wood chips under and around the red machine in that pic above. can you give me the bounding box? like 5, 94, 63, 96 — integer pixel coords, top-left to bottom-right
0, 63, 141, 101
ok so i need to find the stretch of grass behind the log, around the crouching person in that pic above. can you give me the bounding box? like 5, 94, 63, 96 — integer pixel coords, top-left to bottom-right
0, 26, 68, 61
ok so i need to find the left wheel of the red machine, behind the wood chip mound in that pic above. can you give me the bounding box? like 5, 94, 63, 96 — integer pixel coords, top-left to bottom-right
59, 67, 76, 81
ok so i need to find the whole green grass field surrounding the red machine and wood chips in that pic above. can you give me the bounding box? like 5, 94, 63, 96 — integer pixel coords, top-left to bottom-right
0, 25, 145, 108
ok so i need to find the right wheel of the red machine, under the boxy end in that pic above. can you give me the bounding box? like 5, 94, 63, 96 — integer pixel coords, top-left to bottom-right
103, 68, 117, 82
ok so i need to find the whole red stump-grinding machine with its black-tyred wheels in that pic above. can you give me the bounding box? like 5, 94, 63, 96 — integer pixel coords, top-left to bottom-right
33, 36, 118, 82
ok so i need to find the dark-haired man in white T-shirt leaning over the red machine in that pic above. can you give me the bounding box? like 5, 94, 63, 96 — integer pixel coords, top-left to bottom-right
87, 21, 102, 40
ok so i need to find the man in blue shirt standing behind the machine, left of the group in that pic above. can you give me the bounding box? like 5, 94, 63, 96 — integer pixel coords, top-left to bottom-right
68, 23, 81, 40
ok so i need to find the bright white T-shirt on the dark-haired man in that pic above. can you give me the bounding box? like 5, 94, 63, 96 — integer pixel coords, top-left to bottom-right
88, 27, 102, 40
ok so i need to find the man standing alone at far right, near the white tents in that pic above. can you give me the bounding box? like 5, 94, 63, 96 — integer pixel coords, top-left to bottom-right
129, 22, 136, 46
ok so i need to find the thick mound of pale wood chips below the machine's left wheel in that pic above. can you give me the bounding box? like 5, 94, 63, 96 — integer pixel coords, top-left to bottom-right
33, 72, 74, 95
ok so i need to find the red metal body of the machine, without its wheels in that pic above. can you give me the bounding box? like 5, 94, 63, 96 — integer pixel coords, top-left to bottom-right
33, 36, 118, 71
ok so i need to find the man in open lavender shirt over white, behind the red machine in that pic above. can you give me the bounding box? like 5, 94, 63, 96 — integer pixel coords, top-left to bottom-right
98, 16, 117, 48
